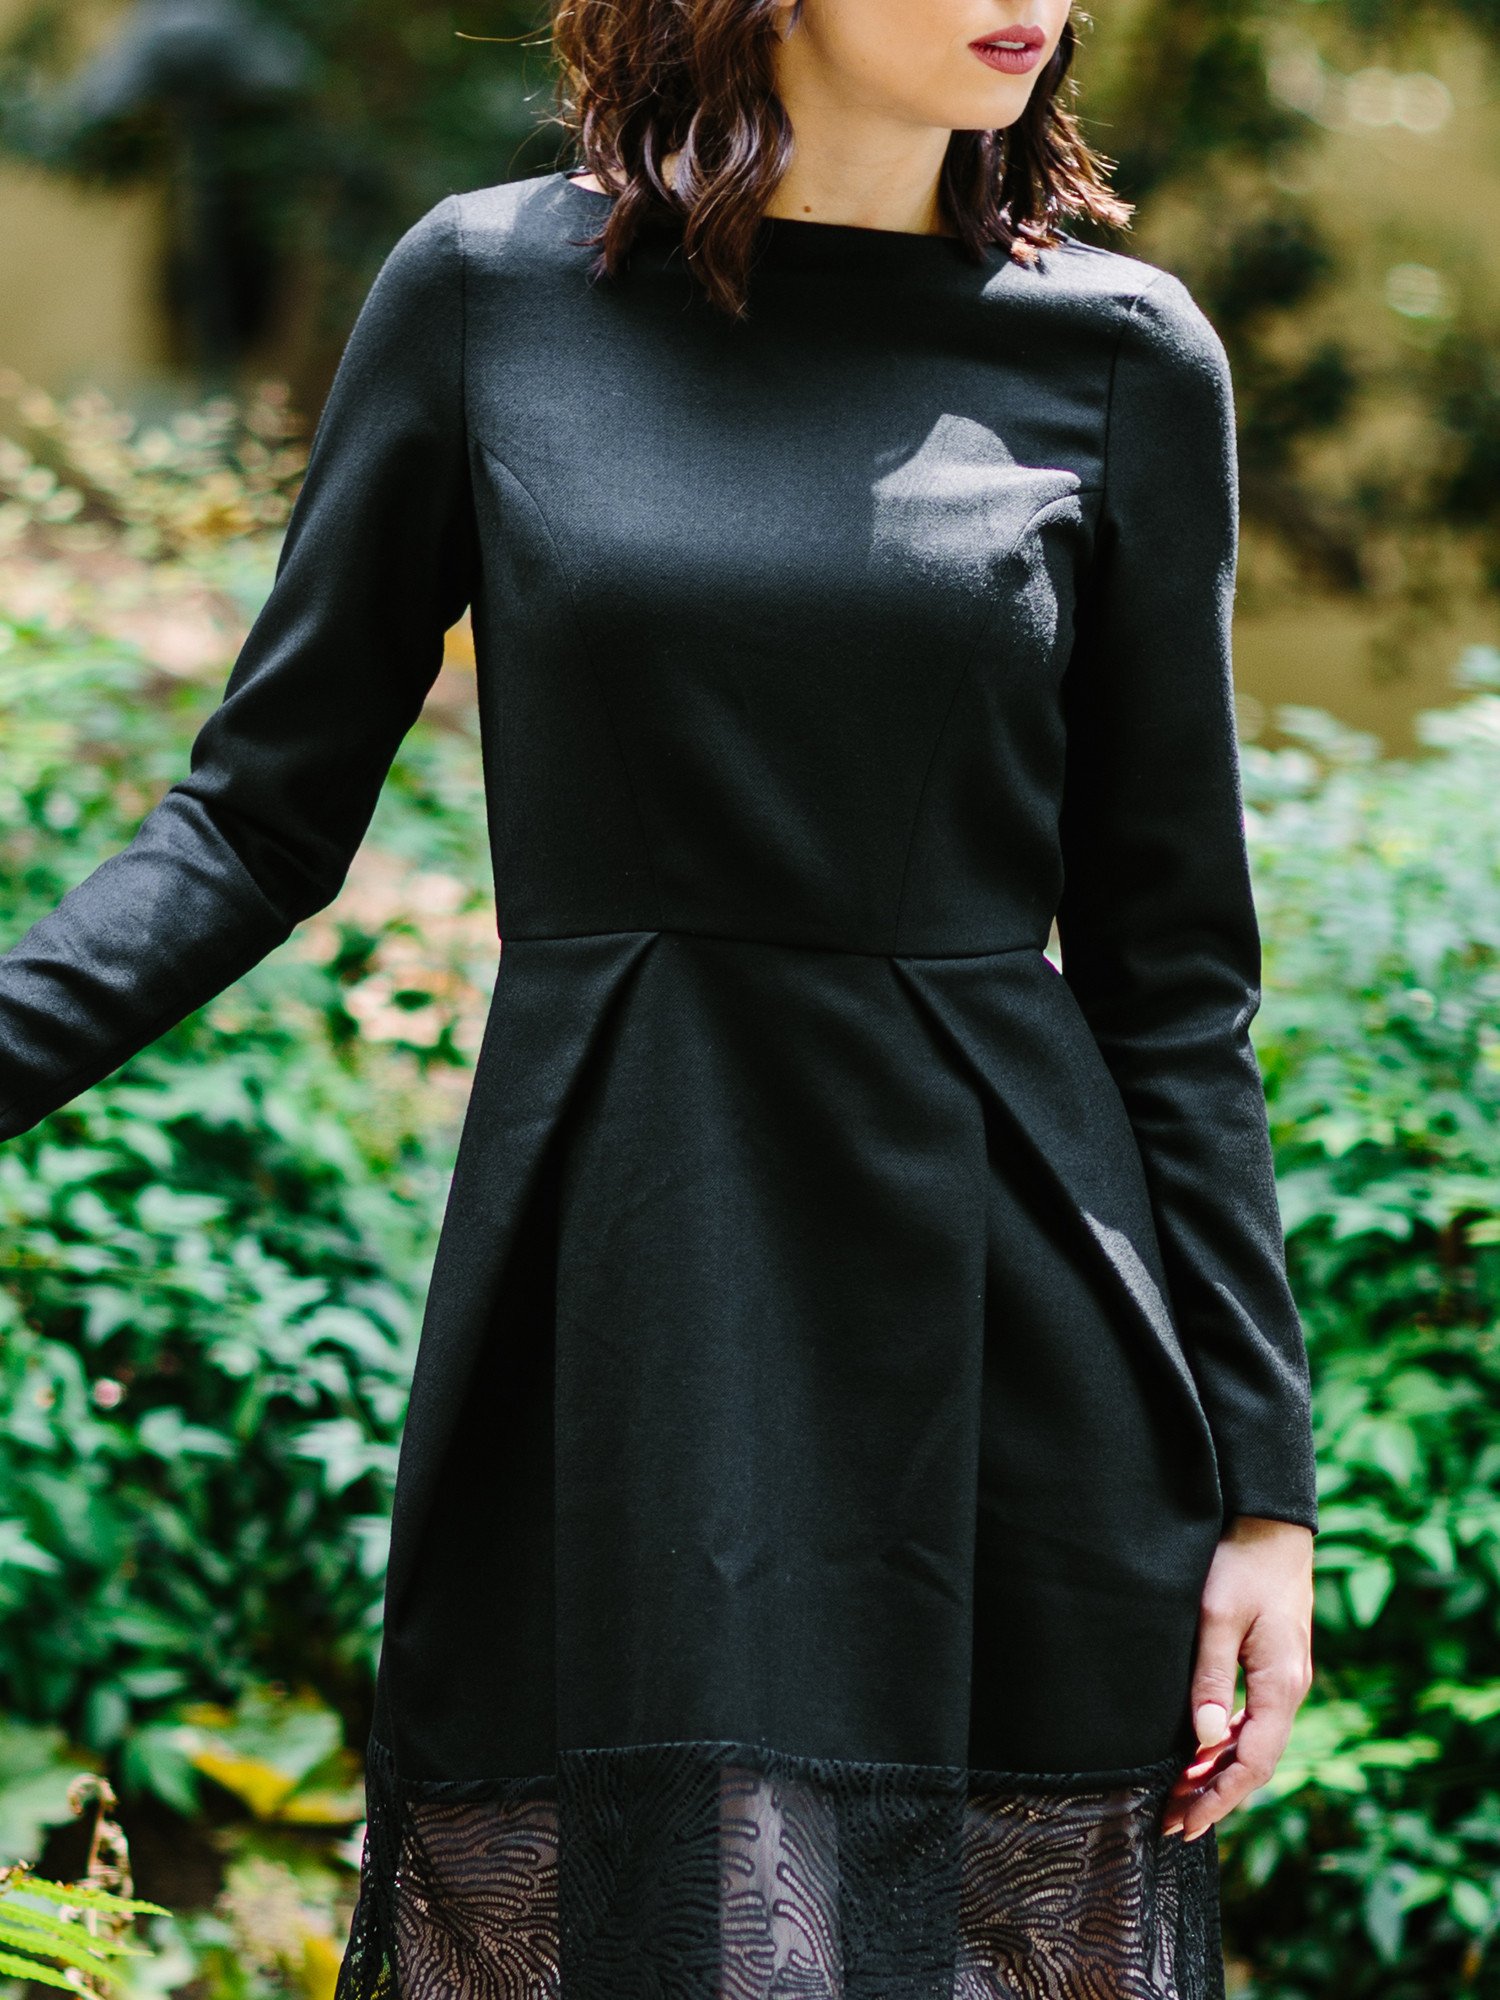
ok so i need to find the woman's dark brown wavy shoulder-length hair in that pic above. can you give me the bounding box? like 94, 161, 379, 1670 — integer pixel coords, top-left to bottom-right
552, 0, 1132, 318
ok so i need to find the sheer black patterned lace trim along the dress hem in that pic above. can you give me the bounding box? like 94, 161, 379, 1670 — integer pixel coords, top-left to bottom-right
336, 1740, 1224, 2000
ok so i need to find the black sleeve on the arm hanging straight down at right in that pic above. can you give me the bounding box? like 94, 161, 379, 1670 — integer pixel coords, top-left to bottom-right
1058, 274, 1318, 1532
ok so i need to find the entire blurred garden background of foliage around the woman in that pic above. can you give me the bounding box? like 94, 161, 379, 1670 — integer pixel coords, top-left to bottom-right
0, 0, 1500, 2000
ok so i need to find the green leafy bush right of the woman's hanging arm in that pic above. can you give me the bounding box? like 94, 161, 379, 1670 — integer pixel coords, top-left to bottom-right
1224, 680, 1500, 2000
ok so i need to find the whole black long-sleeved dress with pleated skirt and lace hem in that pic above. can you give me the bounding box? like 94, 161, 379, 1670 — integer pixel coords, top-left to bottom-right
0, 174, 1316, 2000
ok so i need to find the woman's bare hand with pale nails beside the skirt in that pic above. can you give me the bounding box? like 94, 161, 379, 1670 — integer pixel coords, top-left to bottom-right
1162, 1514, 1312, 1840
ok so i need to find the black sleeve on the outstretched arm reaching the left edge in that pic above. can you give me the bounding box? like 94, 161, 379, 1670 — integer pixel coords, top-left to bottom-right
0, 196, 476, 1138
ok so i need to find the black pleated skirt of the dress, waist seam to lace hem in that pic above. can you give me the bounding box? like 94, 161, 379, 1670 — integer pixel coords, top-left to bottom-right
338, 932, 1222, 2000
